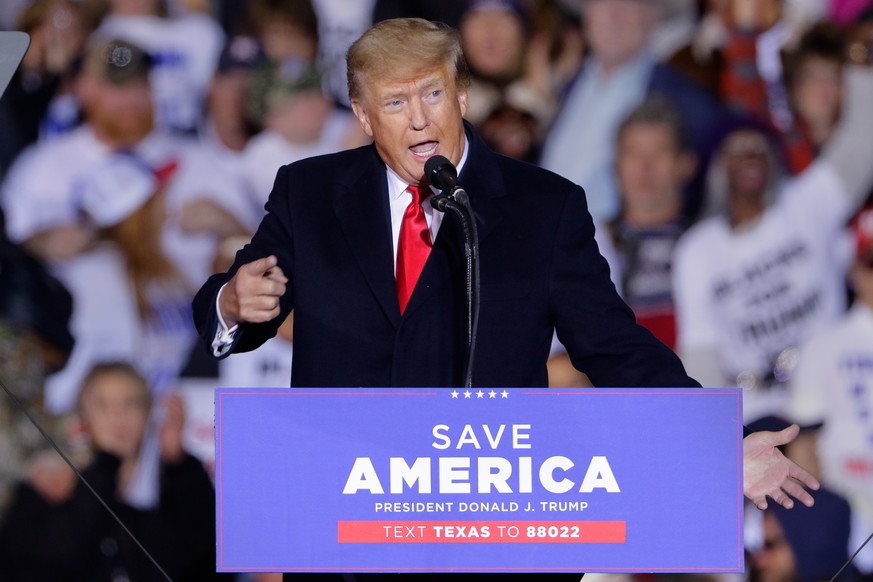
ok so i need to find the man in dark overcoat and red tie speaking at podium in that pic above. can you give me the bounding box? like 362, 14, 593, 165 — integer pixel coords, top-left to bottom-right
194, 19, 817, 576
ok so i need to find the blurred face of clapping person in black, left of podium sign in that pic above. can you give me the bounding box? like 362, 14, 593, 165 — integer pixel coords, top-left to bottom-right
81, 371, 149, 459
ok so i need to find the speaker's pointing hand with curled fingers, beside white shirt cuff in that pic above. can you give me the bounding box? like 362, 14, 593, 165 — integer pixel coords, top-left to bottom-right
218, 255, 288, 327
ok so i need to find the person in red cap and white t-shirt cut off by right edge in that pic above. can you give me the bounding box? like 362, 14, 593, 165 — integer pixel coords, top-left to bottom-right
787, 206, 873, 530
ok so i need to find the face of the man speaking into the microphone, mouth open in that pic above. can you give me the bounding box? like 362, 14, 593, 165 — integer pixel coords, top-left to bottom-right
352, 67, 467, 184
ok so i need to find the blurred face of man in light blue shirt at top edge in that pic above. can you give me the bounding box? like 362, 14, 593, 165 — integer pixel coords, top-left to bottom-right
583, 0, 658, 69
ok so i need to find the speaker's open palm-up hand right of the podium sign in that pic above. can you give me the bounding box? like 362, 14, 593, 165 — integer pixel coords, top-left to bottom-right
743, 424, 820, 510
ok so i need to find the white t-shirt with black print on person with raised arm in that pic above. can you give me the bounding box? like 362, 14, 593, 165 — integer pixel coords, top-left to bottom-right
673, 160, 849, 421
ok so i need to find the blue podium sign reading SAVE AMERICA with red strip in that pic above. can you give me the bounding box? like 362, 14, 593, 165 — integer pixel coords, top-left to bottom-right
215, 388, 743, 573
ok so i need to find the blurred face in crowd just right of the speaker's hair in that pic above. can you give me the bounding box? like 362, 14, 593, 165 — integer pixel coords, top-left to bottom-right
461, 9, 525, 80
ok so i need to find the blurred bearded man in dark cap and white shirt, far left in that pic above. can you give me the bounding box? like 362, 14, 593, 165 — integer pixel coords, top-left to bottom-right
2, 41, 256, 298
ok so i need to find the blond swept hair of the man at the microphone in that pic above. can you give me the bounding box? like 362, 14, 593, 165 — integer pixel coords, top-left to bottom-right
346, 18, 470, 100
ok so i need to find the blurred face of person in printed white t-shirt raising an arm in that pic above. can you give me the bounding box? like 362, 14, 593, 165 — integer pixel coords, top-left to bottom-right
722, 129, 774, 201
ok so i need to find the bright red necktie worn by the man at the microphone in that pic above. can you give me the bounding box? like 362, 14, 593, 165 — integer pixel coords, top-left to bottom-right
396, 185, 433, 313
